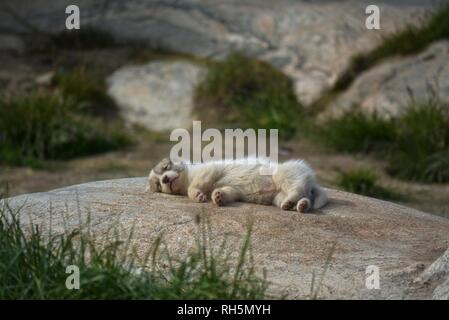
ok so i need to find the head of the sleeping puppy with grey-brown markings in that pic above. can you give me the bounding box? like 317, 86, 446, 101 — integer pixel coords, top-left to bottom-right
146, 158, 185, 194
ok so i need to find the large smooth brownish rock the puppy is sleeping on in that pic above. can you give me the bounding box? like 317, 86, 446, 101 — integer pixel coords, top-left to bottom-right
4, 178, 449, 299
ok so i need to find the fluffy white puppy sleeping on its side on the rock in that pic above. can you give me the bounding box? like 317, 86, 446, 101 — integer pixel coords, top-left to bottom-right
146, 158, 327, 212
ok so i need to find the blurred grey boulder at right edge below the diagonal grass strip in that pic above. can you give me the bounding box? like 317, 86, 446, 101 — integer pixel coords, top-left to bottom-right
329, 40, 449, 117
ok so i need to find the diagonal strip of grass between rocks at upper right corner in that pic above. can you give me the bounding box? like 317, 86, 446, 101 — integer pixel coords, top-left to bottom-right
334, 3, 449, 91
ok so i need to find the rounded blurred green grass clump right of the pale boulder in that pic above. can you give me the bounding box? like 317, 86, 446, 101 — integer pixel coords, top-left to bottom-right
195, 53, 302, 138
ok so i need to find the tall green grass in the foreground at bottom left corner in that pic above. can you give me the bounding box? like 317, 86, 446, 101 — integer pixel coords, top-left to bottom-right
0, 202, 267, 299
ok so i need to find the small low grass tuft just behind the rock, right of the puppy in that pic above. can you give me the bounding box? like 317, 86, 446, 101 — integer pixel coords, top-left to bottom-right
337, 169, 399, 200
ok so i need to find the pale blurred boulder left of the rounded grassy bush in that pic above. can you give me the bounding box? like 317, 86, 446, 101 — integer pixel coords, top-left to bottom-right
107, 61, 205, 131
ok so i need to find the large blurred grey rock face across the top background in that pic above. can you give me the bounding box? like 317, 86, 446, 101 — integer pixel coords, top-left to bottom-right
0, 0, 431, 104
